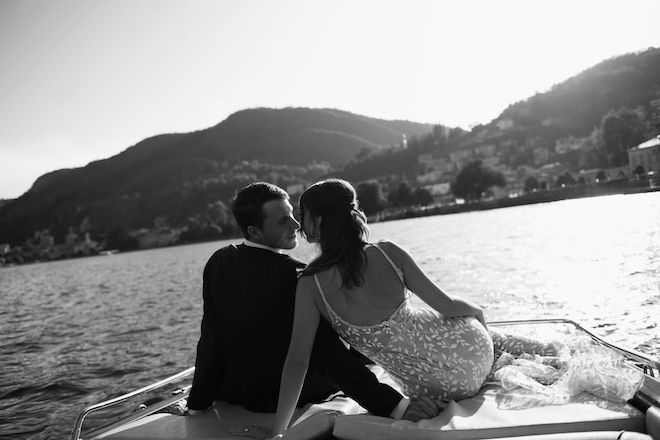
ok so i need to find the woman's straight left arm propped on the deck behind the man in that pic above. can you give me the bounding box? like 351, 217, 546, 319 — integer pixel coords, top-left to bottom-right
272, 279, 321, 435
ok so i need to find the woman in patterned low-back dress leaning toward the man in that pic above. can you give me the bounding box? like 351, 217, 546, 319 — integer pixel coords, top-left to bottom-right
272, 179, 493, 434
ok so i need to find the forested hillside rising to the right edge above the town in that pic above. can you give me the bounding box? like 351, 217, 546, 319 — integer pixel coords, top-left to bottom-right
341, 49, 660, 184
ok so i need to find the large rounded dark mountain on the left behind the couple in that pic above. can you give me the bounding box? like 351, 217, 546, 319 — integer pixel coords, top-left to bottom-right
0, 108, 432, 245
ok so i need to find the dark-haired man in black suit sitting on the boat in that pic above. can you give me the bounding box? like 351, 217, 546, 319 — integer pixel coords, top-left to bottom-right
188, 182, 439, 420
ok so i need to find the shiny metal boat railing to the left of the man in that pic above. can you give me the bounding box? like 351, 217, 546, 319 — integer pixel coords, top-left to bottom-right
70, 367, 195, 440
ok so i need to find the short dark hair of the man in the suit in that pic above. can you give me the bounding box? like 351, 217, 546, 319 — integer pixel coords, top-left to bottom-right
232, 182, 289, 240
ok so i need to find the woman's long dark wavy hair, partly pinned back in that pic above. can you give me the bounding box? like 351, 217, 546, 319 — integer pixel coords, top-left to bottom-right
300, 179, 369, 289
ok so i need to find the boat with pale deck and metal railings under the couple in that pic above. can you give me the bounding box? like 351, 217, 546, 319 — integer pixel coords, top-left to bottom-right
70, 319, 660, 440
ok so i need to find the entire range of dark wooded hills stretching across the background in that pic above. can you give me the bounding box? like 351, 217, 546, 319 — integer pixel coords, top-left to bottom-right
0, 48, 660, 246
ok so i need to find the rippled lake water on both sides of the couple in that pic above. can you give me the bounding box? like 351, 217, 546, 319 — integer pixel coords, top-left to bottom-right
0, 192, 660, 439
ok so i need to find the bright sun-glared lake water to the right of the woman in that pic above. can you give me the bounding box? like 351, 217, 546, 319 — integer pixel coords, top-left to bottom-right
371, 193, 660, 348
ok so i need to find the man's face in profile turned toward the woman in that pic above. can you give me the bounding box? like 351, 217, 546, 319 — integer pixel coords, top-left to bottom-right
253, 200, 300, 249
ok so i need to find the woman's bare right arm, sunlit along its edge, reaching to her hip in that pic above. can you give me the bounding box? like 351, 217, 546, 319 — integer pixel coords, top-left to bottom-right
384, 241, 488, 328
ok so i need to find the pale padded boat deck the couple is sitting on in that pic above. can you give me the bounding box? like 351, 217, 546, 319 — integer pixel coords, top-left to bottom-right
82, 367, 660, 440
